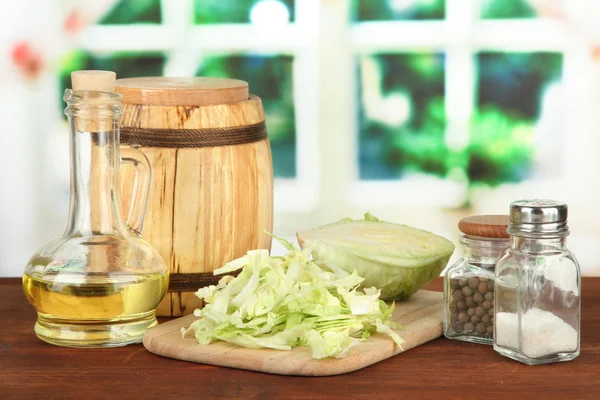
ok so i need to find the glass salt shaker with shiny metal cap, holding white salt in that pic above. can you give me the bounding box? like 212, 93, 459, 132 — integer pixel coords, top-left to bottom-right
494, 200, 581, 365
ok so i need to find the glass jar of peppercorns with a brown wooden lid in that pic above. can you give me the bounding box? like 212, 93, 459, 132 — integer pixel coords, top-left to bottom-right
444, 215, 509, 345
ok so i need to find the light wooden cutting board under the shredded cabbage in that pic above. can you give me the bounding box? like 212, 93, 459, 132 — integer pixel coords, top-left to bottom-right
144, 290, 443, 376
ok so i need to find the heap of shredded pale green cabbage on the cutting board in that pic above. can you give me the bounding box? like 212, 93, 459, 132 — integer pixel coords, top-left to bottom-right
181, 236, 404, 359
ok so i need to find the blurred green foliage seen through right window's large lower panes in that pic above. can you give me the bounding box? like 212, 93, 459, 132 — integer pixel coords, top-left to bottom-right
359, 53, 562, 185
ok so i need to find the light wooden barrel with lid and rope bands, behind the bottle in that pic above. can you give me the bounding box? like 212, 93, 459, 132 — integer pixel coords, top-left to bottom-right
116, 77, 273, 316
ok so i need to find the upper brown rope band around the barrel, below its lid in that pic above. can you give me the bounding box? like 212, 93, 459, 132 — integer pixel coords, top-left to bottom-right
121, 121, 267, 148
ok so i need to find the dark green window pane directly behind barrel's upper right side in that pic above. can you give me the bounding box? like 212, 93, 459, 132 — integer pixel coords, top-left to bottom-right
196, 54, 296, 178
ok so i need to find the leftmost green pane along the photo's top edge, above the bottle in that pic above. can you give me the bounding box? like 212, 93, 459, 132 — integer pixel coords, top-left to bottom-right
98, 0, 161, 25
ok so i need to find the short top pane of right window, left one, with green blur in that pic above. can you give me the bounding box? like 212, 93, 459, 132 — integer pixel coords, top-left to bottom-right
351, 0, 446, 21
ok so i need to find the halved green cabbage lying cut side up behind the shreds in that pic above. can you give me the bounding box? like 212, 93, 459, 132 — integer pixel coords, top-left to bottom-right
297, 213, 454, 300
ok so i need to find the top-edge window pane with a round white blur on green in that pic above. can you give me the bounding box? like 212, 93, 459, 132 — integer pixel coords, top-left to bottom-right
194, 0, 294, 25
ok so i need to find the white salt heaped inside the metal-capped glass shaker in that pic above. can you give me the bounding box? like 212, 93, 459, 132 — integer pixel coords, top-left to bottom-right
495, 308, 578, 358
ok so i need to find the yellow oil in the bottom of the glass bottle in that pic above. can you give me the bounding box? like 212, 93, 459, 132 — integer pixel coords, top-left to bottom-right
23, 273, 168, 347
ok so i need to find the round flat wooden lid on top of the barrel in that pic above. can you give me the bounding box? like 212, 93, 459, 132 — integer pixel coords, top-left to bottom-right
115, 77, 249, 106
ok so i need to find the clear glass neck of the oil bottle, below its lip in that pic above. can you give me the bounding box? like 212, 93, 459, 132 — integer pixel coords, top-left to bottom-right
66, 111, 127, 236
